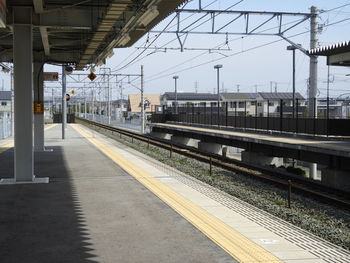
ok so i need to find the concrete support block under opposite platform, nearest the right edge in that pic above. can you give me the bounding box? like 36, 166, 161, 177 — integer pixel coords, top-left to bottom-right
321, 168, 350, 193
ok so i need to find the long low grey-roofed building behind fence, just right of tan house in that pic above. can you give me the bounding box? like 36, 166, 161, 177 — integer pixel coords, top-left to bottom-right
161, 92, 218, 107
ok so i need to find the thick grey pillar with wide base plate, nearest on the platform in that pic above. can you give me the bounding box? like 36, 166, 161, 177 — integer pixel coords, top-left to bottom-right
0, 7, 48, 184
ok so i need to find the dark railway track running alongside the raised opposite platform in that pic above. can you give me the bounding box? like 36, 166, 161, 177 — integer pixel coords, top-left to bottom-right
76, 117, 350, 209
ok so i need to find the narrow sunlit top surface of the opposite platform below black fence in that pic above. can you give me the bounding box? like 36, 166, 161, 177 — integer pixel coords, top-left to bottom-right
154, 123, 350, 150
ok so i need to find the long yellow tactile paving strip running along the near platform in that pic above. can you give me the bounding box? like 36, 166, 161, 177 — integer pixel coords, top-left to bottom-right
72, 125, 282, 263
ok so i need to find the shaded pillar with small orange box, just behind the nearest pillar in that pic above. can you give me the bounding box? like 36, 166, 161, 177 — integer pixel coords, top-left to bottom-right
33, 62, 45, 152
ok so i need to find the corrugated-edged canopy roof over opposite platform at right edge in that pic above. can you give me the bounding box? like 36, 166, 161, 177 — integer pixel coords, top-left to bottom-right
308, 41, 350, 67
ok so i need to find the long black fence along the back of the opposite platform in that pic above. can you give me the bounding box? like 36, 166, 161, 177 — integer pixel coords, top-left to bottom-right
151, 103, 350, 136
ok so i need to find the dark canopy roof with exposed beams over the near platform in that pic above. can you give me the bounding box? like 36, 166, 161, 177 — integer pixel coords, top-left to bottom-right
0, 0, 185, 70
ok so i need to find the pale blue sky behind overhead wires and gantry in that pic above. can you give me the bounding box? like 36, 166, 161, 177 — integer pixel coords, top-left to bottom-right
0, 0, 350, 101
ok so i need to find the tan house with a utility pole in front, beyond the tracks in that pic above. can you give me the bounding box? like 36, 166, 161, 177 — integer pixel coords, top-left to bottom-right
128, 94, 160, 116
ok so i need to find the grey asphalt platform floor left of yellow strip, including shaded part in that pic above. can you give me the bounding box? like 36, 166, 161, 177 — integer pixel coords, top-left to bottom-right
0, 126, 234, 263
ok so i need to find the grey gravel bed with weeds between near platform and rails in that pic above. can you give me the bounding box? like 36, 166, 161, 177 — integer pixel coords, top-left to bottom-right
84, 124, 350, 250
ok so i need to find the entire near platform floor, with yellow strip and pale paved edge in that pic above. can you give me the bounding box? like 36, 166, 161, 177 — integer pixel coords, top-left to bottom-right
0, 124, 350, 263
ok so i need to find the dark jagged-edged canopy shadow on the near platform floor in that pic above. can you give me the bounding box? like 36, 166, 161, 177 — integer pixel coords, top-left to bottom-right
0, 147, 98, 263
